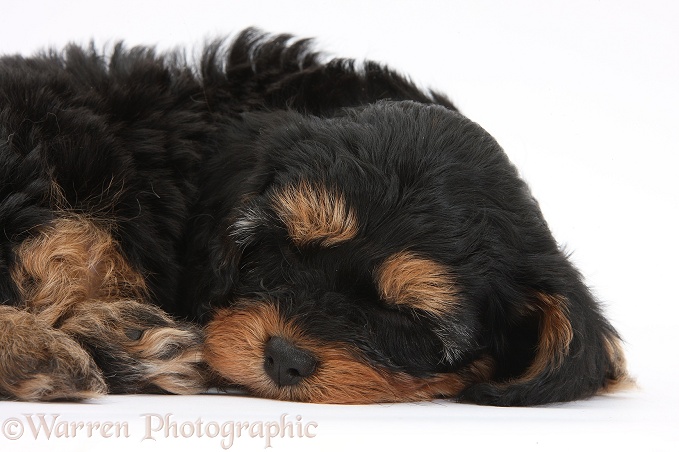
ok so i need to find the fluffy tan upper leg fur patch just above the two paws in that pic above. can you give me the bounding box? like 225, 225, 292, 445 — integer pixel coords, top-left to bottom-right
12, 217, 146, 324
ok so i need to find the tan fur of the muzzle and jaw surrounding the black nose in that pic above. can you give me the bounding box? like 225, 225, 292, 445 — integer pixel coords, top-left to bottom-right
205, 302, 492, 404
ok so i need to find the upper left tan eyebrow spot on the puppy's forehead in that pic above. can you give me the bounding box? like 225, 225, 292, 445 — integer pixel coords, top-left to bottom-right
274, 181, 358, 247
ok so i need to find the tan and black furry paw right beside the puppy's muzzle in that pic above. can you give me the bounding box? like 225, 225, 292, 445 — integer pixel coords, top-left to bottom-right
61, 300, 207, 394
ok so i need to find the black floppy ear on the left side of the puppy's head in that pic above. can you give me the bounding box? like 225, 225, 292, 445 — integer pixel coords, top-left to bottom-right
178, 113, 294, 321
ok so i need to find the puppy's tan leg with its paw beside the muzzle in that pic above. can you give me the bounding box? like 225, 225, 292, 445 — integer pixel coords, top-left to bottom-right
13, 216, 203, 393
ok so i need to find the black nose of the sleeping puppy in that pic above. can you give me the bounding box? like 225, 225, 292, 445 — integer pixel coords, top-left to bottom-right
264, 336, 318, 386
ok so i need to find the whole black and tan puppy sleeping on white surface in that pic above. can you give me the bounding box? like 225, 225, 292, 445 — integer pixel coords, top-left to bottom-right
0, 30, 626, 405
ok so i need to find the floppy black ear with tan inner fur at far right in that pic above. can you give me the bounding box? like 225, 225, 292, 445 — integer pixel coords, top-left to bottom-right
460, 285, 630, 406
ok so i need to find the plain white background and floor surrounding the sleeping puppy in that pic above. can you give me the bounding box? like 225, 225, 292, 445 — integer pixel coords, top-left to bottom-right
0, 0, 679, 451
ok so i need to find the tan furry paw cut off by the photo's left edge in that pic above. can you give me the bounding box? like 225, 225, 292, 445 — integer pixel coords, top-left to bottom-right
0, 306, 106, 401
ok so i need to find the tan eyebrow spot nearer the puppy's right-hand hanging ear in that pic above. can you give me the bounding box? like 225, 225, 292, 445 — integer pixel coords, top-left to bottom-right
375, 251, 457, 315
